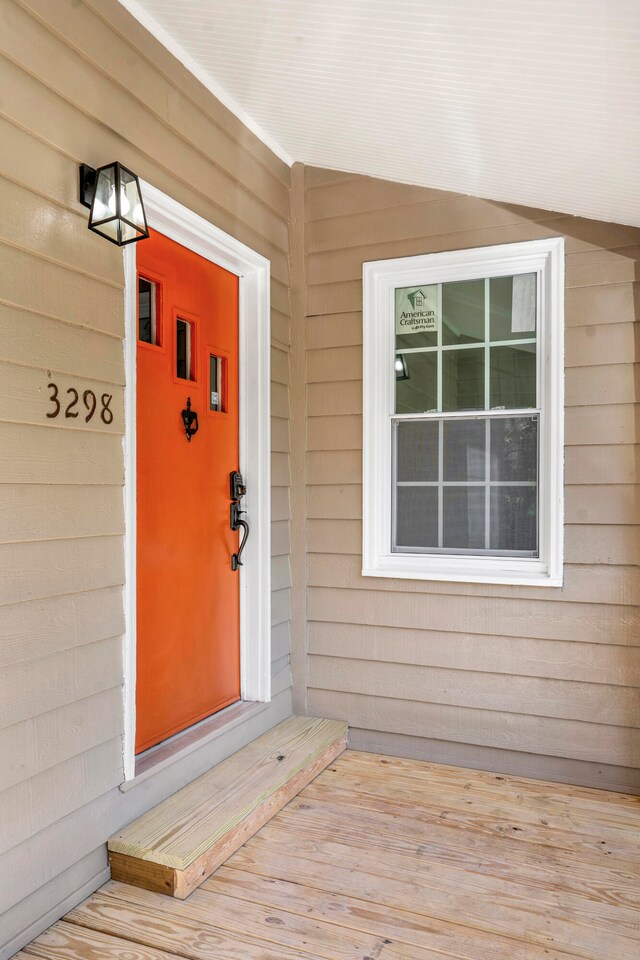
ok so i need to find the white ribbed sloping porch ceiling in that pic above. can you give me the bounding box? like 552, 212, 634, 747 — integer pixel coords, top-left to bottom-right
121, 0, 640, 225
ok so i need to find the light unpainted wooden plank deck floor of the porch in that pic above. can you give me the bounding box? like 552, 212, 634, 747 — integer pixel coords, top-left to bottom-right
15, 752, 640, 960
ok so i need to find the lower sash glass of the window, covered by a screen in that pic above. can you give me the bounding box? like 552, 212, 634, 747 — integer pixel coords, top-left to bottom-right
394, 415, 538, 556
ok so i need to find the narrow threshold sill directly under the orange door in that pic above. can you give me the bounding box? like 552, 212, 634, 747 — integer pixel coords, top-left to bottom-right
119, 700, 270, 793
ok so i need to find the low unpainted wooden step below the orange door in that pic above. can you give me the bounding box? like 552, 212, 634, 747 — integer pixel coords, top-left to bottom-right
109, 717, 347, 900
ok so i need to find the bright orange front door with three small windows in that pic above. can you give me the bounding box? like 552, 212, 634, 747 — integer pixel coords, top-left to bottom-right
136, 232, 240, 753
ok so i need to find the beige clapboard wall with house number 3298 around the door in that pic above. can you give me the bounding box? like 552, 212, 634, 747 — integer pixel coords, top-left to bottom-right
0, 0, 291, 957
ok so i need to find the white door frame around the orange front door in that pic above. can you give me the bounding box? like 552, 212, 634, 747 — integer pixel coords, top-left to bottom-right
123, 181, 271, 780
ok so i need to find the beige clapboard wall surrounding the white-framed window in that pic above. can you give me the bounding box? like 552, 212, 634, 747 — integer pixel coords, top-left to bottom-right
292, 167, 640, 791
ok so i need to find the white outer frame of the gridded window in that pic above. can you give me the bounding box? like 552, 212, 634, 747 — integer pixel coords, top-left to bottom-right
362, 237, 564, 587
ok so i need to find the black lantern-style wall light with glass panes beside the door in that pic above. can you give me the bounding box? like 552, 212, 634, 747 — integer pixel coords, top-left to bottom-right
80, 163, 149, 247
